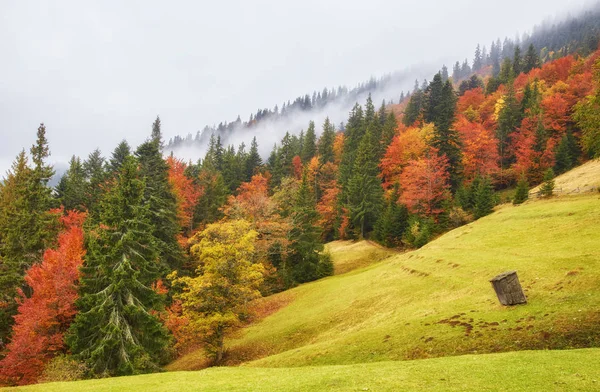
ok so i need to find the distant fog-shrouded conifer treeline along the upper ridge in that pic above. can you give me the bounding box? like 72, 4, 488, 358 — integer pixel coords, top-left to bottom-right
166, 4, 600, 151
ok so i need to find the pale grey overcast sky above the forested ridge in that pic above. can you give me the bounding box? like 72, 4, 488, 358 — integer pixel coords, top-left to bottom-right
0, 0, 589, 177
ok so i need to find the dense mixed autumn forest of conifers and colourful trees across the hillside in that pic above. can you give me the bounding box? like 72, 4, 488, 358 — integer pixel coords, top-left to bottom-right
0, 8, 600, 385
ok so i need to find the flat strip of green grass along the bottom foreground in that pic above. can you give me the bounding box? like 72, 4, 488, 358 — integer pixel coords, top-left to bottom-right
5, 349, 600, 392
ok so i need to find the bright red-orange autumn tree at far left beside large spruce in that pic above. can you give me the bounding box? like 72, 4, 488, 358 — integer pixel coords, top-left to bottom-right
0, 211, 86, 385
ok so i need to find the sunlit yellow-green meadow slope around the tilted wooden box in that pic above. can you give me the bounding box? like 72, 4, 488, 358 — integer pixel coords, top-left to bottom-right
168, 194, 600, 370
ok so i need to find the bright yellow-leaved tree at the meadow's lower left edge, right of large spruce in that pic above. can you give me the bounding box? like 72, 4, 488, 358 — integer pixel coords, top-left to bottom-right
174, 220, 264, 364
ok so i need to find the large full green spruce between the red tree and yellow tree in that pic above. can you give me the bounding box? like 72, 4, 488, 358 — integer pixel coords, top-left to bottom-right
67, 156, 169, 376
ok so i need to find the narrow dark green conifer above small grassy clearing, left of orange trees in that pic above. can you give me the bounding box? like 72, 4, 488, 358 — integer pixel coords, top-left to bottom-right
348, 131, 383, 238
